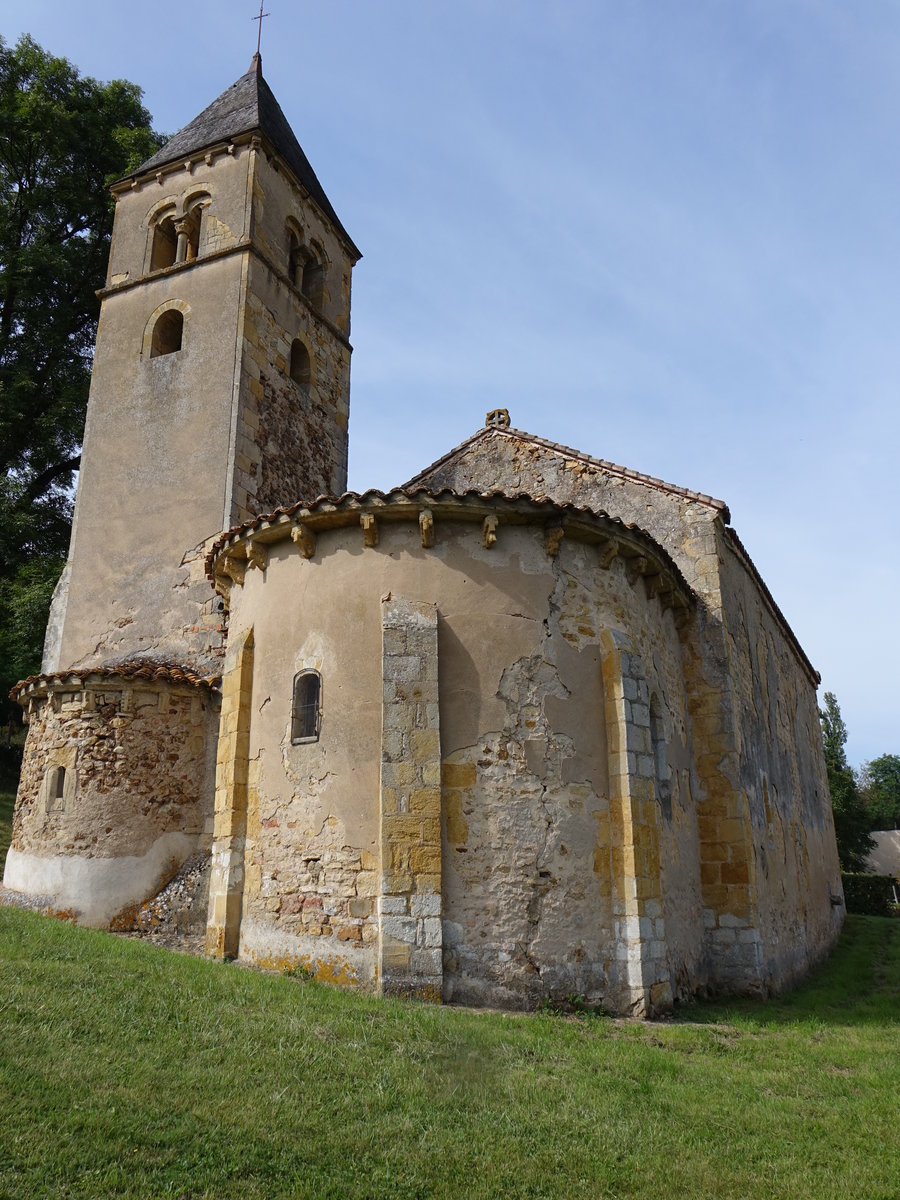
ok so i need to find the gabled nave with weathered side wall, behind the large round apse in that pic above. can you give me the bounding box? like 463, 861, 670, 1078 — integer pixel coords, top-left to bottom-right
427, 432, 840, 991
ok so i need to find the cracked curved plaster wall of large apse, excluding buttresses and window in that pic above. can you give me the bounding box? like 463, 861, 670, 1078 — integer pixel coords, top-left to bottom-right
224, 522, 702, 1007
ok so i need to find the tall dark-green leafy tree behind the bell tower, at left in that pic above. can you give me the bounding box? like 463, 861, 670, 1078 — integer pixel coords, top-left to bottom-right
0, 37, 161, 720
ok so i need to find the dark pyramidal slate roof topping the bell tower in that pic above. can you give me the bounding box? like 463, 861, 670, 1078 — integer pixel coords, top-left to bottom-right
134, 54, 360, 257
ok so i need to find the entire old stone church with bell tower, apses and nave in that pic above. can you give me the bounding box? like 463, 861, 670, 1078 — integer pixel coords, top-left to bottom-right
4, 55, 844, 1015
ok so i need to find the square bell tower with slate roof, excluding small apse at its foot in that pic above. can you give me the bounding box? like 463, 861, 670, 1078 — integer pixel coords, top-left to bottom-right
43, 54, 360, 672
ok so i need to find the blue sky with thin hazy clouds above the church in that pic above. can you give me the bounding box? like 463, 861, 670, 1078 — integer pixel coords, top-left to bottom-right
0, 0, 900, 764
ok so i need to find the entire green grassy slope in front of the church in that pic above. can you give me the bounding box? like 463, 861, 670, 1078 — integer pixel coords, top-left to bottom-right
0, 910, 900, 1200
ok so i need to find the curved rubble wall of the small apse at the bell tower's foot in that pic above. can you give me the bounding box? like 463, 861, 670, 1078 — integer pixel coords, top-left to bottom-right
4, 677, 218, 926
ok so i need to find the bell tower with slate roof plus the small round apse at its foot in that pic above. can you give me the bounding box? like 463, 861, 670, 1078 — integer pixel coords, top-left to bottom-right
4, 54, 360, 928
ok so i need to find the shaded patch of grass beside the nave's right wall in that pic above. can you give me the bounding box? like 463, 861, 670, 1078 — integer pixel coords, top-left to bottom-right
677, 916, 900, 1026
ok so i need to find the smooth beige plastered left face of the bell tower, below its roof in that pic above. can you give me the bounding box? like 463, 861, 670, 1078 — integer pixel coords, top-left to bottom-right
50, 152, 247, 672
